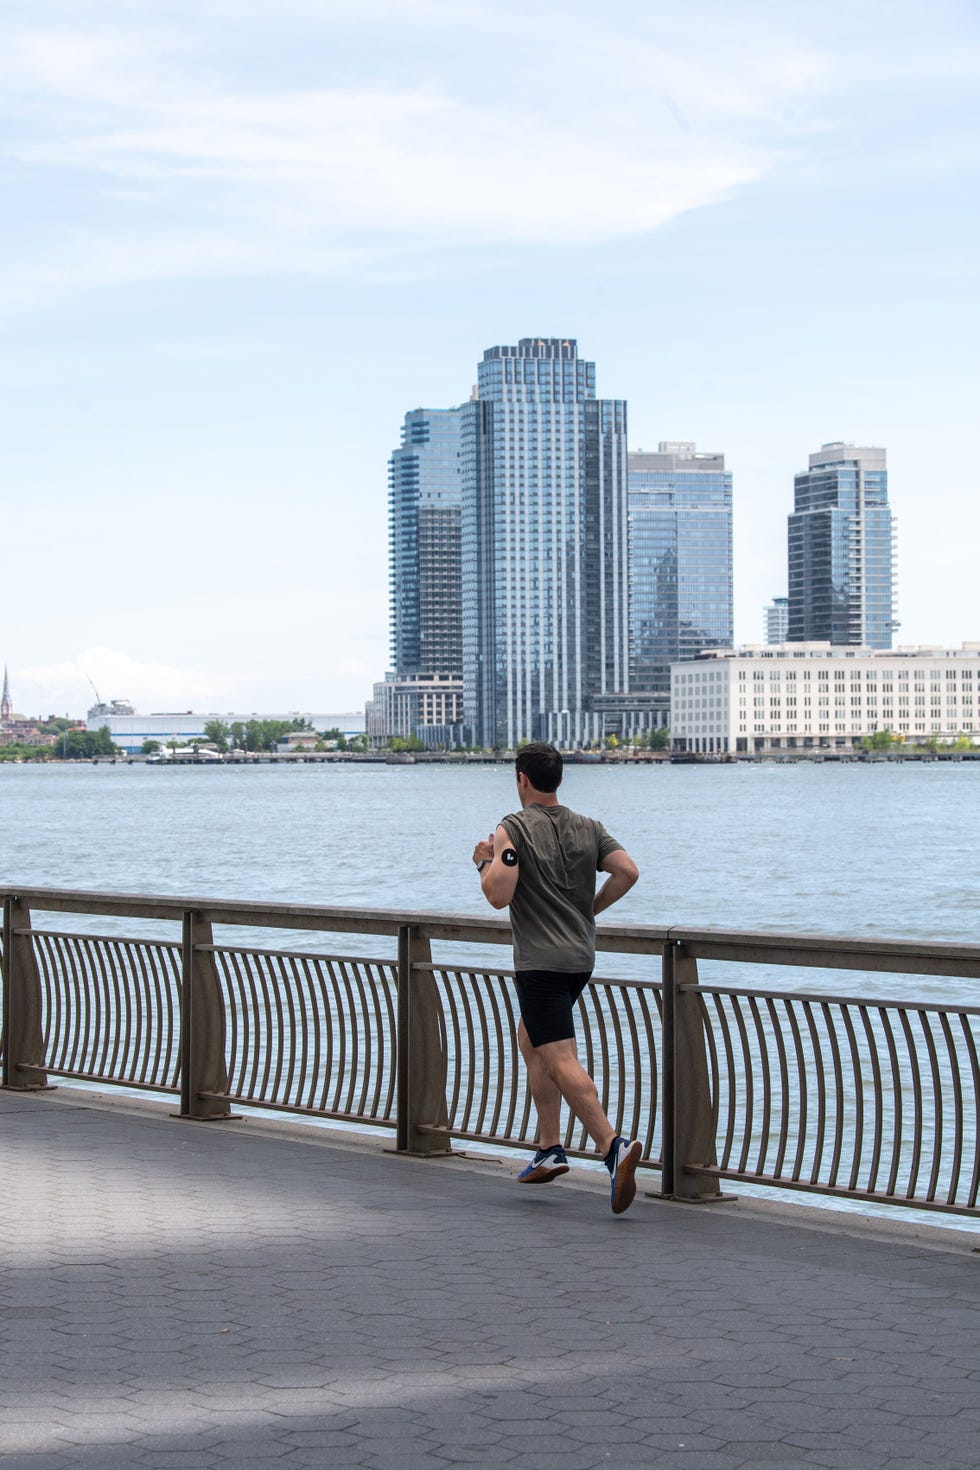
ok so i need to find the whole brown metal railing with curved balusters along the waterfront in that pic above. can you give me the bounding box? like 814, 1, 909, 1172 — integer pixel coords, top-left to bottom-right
0, 889, 980, 1216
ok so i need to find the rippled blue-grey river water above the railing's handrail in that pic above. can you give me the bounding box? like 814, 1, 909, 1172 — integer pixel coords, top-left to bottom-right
0, 763, 980, 942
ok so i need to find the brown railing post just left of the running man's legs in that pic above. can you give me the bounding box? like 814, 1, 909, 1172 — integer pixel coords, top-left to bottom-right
395, 925, 453, 1155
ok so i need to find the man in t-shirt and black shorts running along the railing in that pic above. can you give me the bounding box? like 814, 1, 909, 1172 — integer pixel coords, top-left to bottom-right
473, 744, 642, 1214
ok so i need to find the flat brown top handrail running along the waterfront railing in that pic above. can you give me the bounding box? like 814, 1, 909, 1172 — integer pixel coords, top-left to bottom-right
0, 885, 980, 978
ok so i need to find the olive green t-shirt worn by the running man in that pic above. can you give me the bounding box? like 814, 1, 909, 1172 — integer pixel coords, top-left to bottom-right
501, 804, 621, 975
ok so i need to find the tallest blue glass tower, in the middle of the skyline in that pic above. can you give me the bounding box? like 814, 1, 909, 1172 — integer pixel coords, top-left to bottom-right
460, 337, 629, 747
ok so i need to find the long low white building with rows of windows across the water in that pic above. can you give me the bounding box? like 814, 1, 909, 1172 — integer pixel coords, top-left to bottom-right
670, 642, 980, 754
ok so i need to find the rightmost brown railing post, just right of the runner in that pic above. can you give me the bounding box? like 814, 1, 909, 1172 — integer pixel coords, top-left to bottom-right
663, 939, 721, 1201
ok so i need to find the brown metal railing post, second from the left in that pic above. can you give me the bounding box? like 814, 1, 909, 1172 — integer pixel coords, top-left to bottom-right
181, 910, 232, 1120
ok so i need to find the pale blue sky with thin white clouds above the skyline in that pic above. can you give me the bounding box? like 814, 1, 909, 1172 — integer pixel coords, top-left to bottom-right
0, 0, 980, 714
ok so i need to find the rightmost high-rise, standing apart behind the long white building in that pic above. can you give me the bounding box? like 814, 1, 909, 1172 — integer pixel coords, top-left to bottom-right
788, 444, 898, 648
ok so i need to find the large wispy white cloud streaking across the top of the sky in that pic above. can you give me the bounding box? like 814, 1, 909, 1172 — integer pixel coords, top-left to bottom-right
0, 4, 826, 298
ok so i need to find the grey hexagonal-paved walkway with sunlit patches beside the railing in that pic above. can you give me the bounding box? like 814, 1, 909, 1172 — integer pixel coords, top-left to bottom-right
0, 1089, 980, 1470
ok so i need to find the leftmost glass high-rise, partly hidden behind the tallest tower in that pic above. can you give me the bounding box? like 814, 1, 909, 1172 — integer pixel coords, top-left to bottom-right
388, 409, 463, 678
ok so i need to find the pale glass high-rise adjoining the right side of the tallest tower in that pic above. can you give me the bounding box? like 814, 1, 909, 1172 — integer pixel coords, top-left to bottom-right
629, 442, 735, 697
